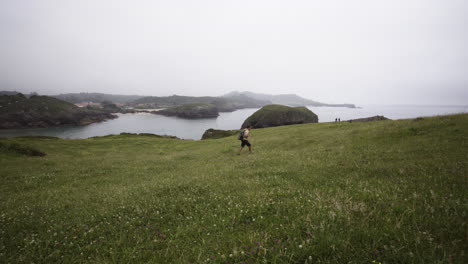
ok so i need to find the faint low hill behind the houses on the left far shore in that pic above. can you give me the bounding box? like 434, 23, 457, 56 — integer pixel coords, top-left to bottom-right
53, 93, 144, 104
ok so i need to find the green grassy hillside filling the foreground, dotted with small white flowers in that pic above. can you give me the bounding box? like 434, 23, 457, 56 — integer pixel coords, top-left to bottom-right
0, 114, 468, 263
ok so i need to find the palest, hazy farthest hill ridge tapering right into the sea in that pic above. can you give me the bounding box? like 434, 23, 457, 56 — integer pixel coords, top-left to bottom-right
223, 91, 356, 108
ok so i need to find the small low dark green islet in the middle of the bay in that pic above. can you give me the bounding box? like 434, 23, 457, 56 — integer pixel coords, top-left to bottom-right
153, 104, 219, 119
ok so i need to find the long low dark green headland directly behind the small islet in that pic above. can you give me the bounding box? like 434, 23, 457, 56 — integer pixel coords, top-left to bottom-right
129, 95, 269, 112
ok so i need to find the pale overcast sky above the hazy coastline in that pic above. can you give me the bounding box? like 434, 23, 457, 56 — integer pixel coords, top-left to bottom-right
0, 0, 468, 105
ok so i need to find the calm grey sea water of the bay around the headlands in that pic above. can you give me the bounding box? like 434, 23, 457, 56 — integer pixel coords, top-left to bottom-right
0, 105, 468, 140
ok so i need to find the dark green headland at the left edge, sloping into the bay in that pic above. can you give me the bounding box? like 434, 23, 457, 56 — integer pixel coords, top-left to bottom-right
0, 94, 116, 129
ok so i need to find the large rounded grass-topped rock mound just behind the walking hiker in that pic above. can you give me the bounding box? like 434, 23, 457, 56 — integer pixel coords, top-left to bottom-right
241, 105, 318, 128
